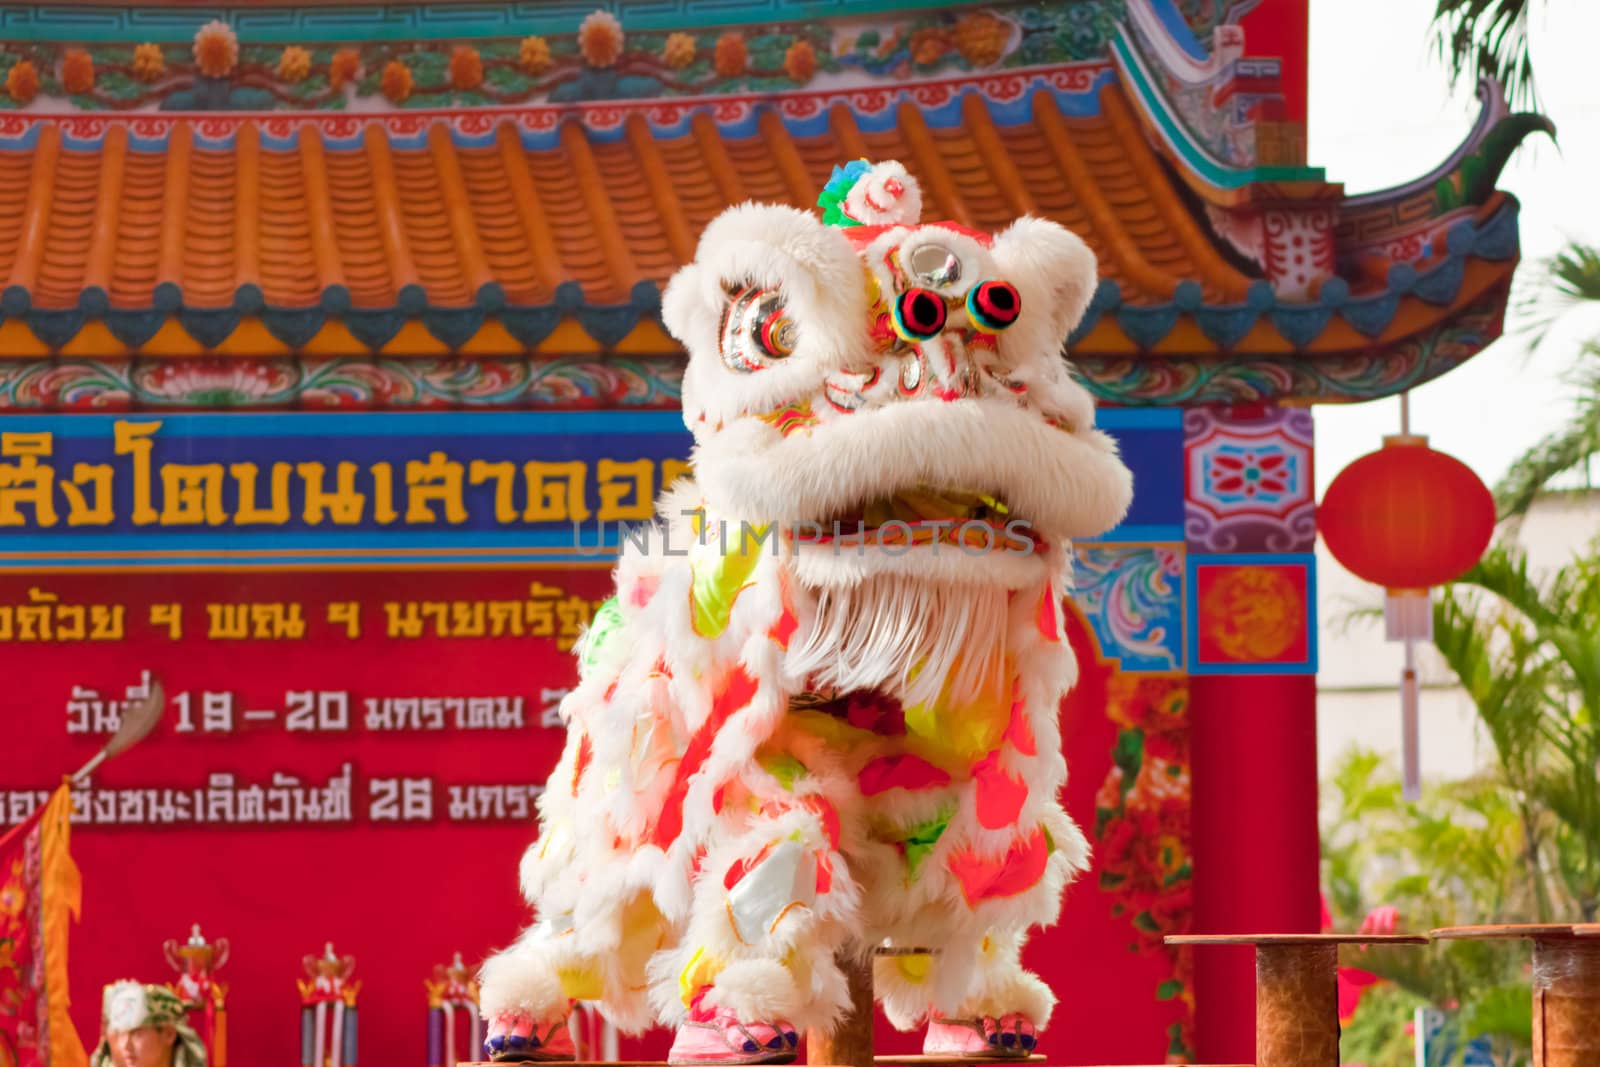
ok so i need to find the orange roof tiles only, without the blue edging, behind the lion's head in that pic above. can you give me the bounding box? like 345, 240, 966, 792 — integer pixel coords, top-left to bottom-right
0, 88, 1248, 316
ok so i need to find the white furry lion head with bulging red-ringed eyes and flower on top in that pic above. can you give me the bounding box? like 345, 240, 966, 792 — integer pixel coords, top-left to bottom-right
662, 163, 1131, 589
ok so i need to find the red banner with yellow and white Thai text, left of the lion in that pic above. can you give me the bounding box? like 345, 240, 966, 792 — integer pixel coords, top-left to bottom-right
0, 568, 610, 1067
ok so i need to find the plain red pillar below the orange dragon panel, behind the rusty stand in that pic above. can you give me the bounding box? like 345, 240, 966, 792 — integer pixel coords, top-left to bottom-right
1189, 675, 1322, 1064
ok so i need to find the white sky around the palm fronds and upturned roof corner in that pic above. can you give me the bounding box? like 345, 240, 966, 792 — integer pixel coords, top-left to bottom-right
1307, 0, 1600, 499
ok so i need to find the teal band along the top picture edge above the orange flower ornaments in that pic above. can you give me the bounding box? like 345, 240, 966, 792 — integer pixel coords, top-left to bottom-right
0, 0, 971, 45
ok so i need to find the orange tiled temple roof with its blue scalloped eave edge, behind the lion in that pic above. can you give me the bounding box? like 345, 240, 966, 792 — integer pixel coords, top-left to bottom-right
0, 64, 1515, 367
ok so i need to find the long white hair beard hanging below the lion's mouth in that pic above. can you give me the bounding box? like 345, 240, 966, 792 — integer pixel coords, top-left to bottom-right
784, 574, 1010, 707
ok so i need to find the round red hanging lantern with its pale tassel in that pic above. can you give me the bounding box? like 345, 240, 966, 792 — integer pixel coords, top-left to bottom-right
1317, 435, 1494, 800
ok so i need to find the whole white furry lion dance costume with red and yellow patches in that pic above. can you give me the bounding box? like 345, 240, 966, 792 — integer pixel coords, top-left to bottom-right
482, 162, 1131, 1064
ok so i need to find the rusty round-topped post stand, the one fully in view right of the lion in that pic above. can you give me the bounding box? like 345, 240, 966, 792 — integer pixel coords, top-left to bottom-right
1166, 934, 1427, 1067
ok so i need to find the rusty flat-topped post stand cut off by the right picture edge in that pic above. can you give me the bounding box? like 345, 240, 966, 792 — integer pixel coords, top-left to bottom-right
1434, 923, 1600, 1067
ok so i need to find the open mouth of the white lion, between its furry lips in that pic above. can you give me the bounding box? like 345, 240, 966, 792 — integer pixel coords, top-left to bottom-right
794, 486, 1046, 553
